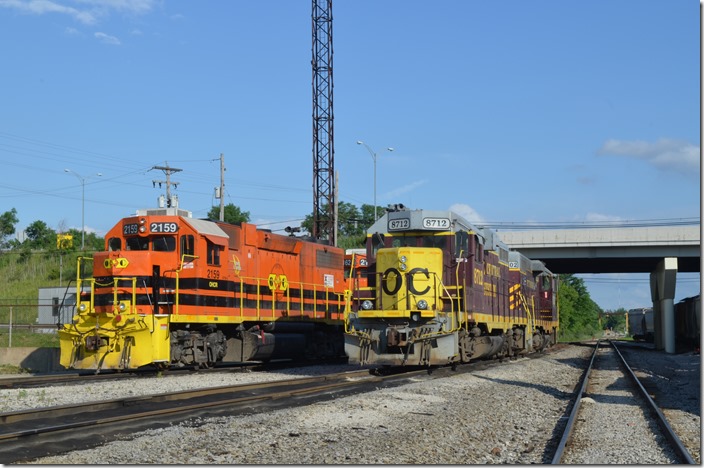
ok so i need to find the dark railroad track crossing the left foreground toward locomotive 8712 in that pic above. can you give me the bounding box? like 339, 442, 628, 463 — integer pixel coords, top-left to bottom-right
0, 368, 470, 464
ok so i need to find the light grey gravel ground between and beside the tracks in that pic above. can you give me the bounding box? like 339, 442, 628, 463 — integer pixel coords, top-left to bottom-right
0, 346, 701, 464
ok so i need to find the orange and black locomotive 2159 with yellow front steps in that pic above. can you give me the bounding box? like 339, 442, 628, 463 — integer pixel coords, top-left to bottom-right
59, 208, 346, 369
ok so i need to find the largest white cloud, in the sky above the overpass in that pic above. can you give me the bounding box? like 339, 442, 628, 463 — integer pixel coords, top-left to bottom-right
597, 138, 700, 175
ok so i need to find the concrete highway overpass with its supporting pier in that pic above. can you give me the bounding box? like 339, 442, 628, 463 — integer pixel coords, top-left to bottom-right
499, 225, 701, 353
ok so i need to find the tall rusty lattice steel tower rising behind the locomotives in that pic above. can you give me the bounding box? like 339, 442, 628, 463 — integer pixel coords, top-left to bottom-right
311, 0, 336, 245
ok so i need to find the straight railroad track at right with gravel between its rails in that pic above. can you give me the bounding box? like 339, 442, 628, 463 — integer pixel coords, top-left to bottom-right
552, 342, 696, 464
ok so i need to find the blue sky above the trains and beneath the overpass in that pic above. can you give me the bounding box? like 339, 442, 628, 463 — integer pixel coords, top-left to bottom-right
0, 0, 701, 310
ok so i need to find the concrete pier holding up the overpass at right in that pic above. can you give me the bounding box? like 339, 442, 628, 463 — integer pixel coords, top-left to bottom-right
650, 257, 677, 353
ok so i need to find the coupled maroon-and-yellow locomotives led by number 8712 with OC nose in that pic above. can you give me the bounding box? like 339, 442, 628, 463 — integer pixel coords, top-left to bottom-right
345, 205, 559, 366
